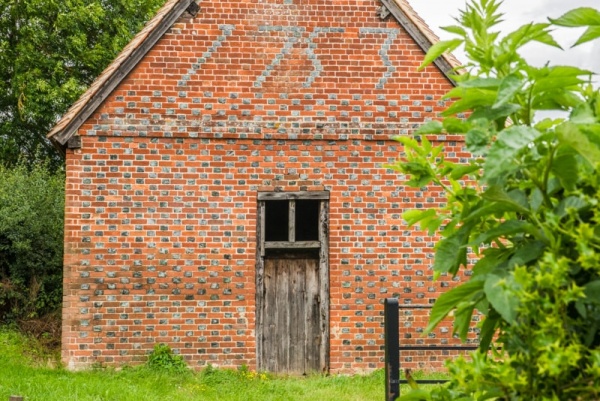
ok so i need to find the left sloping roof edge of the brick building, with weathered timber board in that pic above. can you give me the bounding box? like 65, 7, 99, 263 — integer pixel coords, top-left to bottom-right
47, 0, 198, 148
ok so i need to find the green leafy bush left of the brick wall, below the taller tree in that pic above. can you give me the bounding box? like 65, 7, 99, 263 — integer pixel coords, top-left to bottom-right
0, 161, 65, 322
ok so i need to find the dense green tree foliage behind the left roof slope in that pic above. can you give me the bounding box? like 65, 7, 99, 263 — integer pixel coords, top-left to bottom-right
0, 0, 164, 166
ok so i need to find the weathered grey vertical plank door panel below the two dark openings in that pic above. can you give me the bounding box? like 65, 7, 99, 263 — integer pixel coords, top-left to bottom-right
262, 254, 322, 374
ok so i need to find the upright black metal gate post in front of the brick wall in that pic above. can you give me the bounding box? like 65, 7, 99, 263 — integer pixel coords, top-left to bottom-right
383, 298, 400, 401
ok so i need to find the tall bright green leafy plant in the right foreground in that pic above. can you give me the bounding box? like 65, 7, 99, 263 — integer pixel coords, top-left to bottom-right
391, 0, 600, 400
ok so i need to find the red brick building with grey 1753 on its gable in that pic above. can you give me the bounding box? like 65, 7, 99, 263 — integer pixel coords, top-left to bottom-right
49, 0, 464, 373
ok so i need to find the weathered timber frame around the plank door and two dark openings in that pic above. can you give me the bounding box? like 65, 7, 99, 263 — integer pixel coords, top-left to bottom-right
255, 191, 330, 373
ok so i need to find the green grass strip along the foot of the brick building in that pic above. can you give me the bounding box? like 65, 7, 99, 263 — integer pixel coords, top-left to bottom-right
0, 330, 442, 401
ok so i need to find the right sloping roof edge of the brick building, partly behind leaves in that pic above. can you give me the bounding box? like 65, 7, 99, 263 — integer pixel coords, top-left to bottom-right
380, 0, 461, 86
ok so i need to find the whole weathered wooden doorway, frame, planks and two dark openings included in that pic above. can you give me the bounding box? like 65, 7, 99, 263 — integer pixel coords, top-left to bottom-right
256, 192, 329, 374
